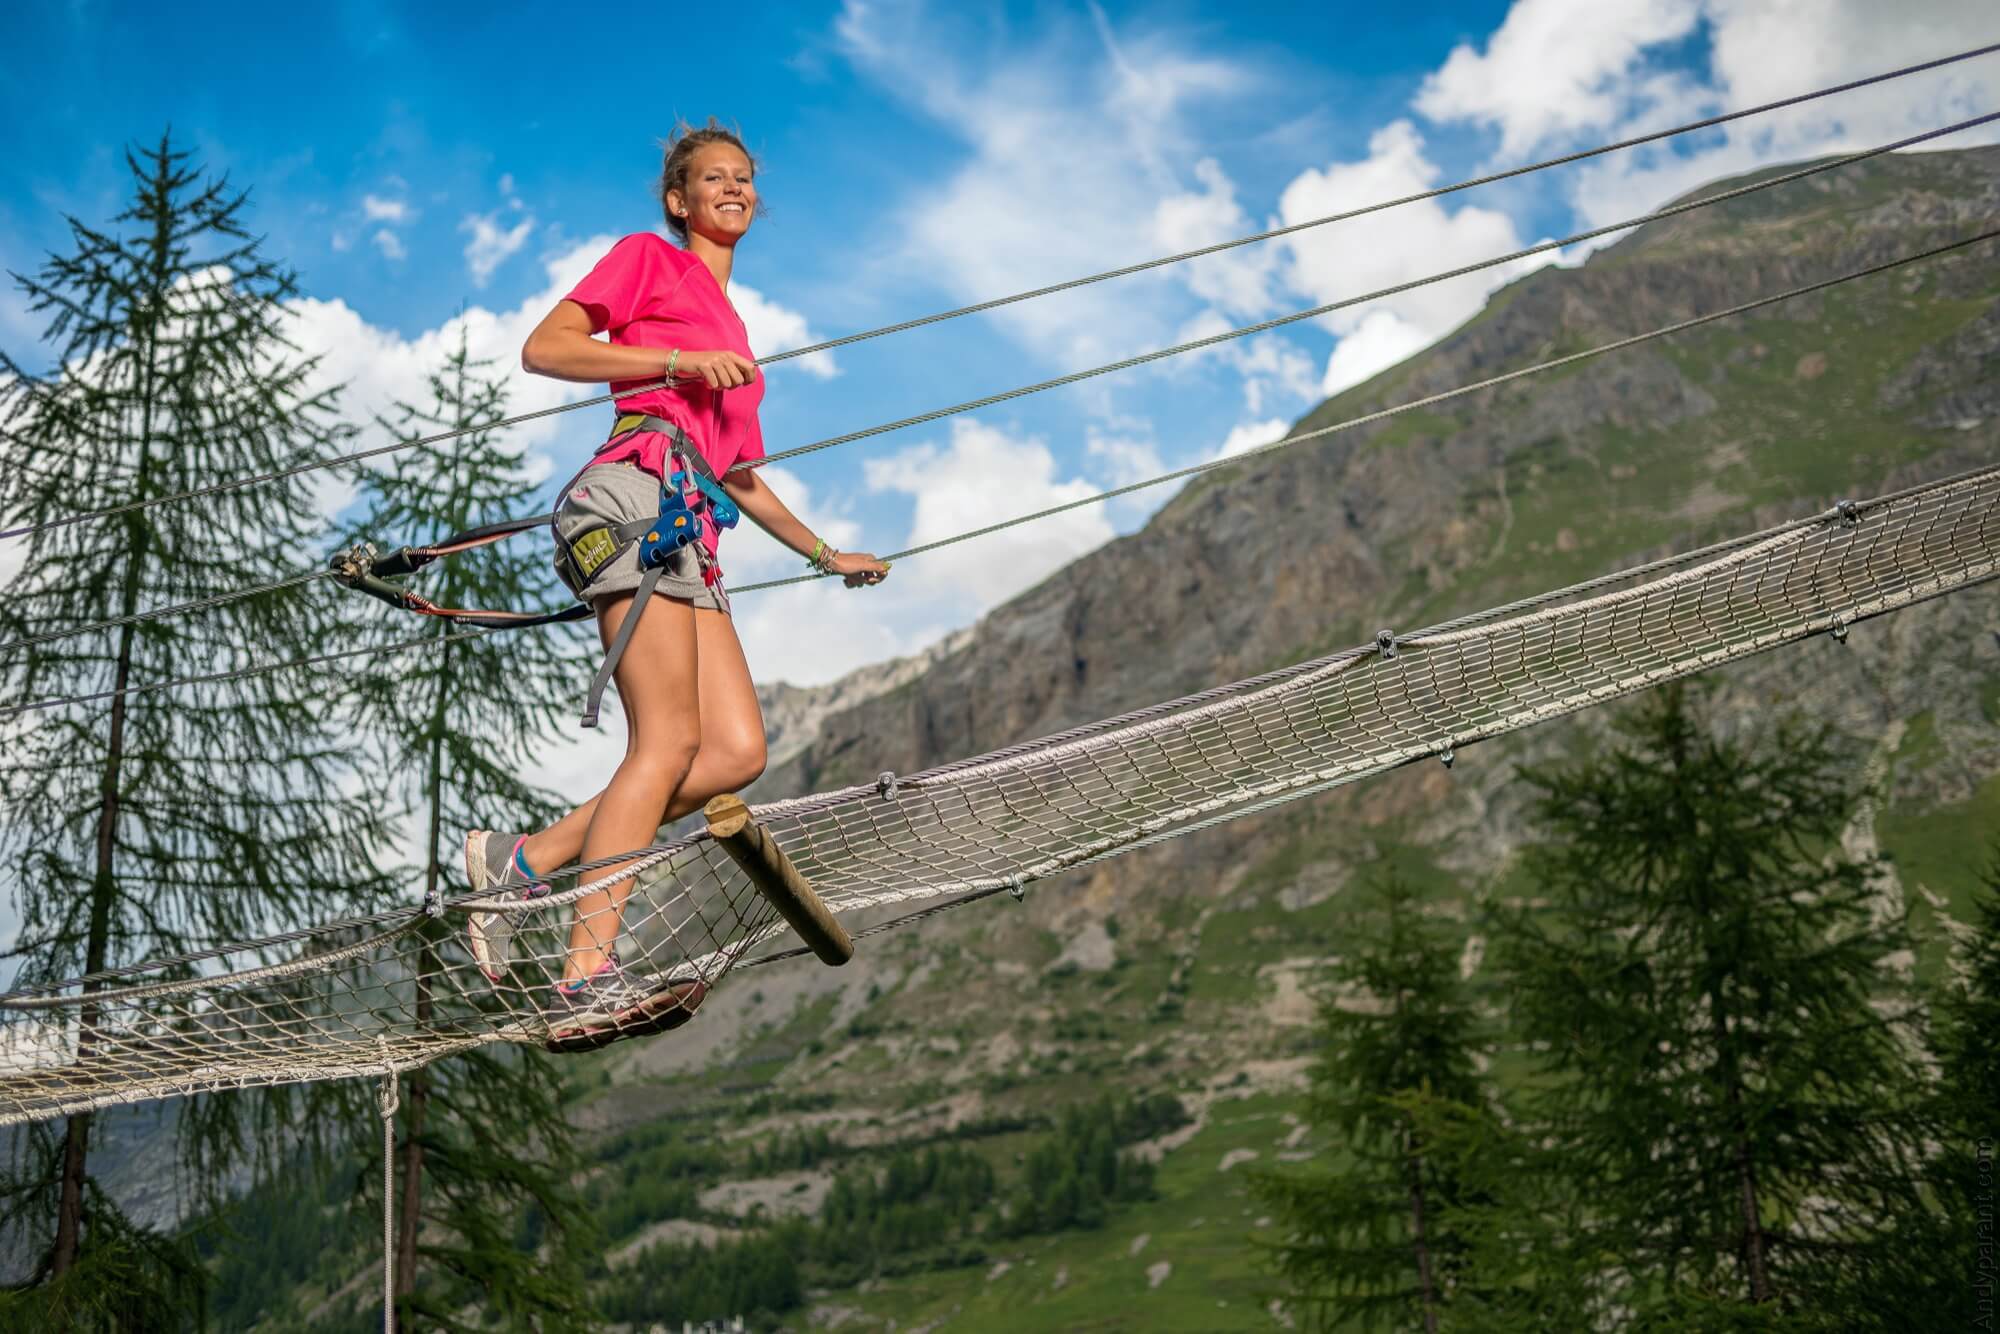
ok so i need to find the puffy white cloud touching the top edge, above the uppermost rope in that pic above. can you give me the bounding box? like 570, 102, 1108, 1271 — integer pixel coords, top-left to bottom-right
1414, 0, 1704, 160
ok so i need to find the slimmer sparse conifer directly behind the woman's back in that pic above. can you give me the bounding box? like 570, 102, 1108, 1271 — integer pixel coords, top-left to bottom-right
336, 330, 594, 1328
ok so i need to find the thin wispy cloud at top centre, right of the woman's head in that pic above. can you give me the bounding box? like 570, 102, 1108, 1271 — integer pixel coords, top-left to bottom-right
836, 0, 1254, 366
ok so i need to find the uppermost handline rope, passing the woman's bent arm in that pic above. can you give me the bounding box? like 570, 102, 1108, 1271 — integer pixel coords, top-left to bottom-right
0, 42, 2000, 542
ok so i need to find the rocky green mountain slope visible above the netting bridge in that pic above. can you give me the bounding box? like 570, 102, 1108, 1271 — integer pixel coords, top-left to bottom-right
762, 148, 2000, 808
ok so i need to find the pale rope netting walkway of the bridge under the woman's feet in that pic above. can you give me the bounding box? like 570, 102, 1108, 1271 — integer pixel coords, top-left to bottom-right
0, 468, 2000, 1124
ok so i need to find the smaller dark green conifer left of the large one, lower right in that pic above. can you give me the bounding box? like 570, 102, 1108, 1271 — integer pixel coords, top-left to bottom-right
1252, 874, 1486, 1334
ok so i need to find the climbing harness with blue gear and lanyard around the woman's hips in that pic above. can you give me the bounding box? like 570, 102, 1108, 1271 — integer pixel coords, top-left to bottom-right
328, 412, 742, 728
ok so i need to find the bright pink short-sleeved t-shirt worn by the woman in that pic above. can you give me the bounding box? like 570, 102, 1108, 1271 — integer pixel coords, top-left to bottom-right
568, 232, 764, 552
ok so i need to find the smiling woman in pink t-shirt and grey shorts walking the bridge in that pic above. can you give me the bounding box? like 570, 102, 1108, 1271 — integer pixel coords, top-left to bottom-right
466, 120, 888, 1046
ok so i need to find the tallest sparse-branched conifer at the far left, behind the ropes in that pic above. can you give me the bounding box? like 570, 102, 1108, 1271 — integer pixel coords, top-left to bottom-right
0, 136, 394, 1318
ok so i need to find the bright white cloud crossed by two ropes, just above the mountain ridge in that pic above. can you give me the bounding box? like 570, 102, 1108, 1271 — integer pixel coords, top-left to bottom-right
1278, 120, 1548, 394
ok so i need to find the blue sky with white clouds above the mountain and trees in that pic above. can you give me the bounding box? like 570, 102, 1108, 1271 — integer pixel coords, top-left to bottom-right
0, 0, 2000, 708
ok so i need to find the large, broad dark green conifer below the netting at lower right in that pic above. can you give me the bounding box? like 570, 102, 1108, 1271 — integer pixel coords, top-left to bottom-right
1494, 686, 1920, 1328
